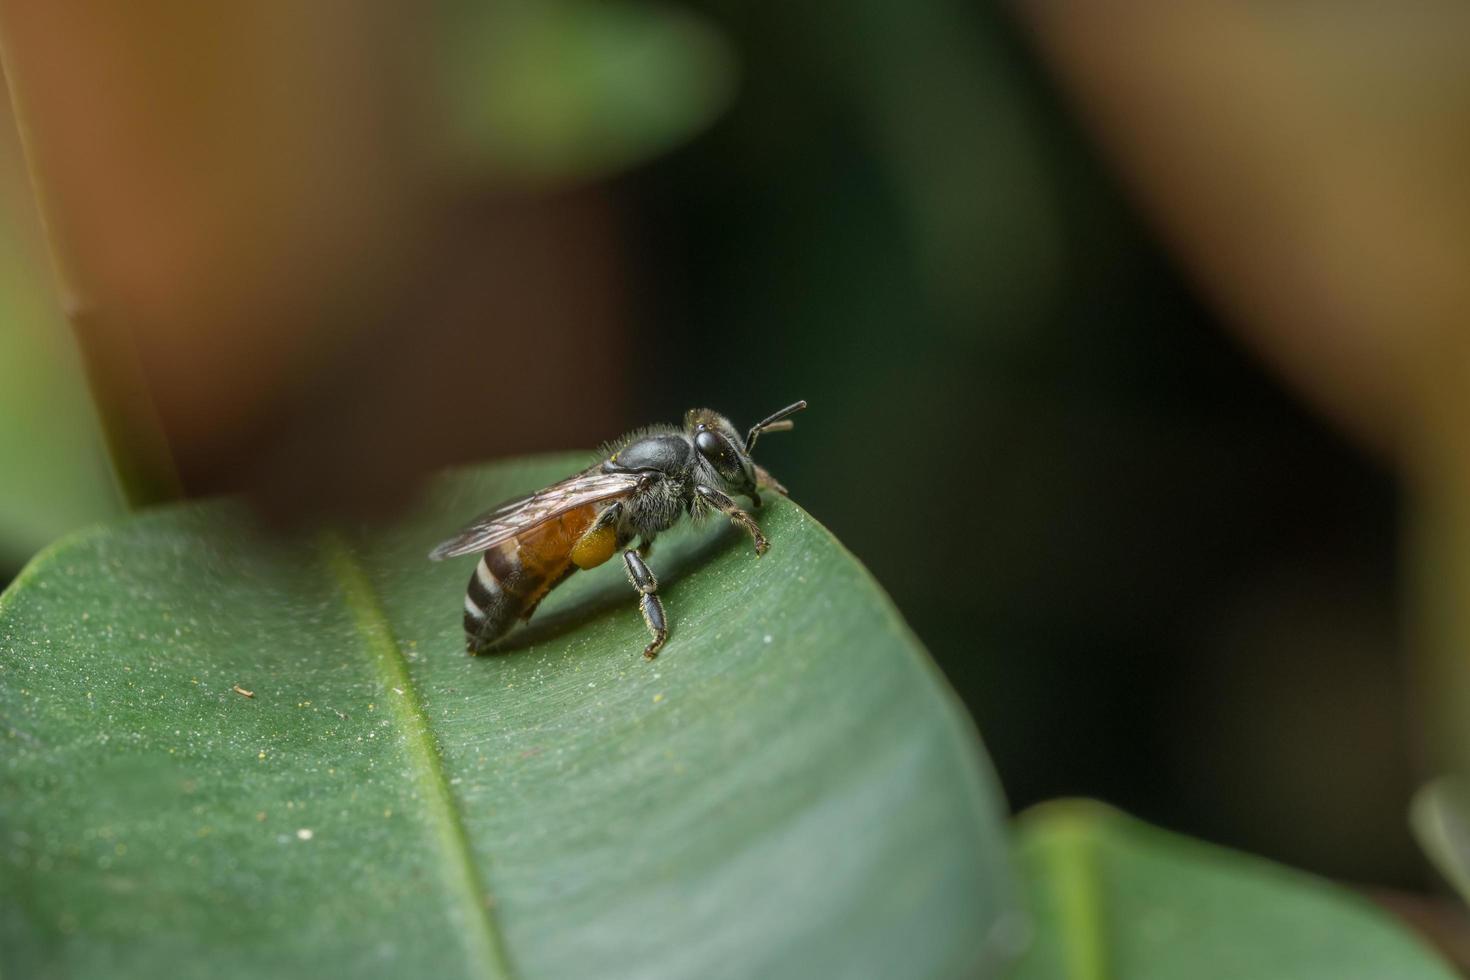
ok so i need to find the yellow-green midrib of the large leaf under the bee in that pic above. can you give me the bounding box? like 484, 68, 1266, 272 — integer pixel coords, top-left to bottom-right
320, 532, 513, 980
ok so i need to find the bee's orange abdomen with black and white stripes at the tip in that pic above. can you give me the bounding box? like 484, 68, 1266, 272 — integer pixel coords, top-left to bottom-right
465, 507, 597, 654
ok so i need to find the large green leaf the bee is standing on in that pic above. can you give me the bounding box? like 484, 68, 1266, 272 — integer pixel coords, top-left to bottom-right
0, 457, 1019, 977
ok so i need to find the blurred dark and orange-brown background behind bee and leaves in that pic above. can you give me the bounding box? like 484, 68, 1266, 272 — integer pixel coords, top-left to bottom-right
0, 0, 1470, 910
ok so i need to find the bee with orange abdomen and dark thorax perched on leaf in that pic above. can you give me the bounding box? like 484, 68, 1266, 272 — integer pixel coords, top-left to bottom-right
429, 401, 807, 660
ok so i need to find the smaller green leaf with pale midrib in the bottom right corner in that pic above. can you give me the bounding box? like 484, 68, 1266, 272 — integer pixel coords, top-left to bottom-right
1016, 801, 1455, 980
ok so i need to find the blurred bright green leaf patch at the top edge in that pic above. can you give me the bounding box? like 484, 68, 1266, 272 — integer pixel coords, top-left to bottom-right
441, 0, 735, 179
